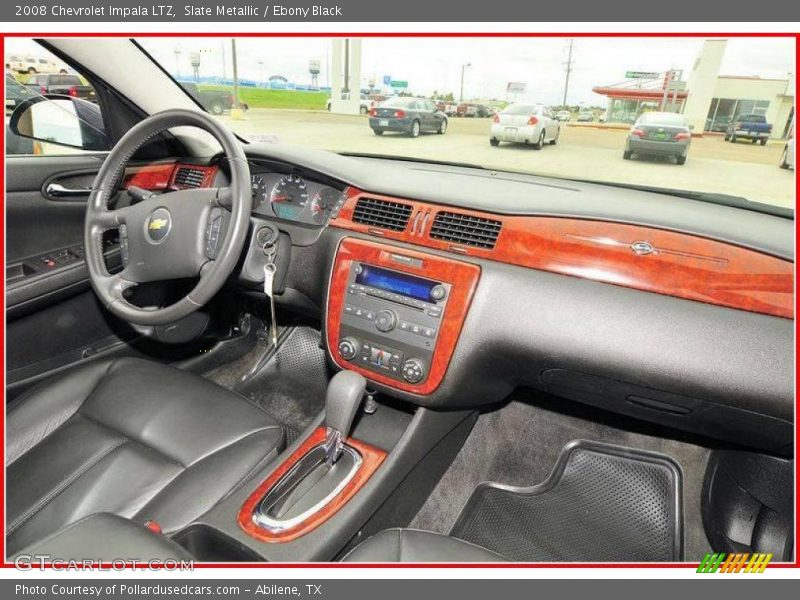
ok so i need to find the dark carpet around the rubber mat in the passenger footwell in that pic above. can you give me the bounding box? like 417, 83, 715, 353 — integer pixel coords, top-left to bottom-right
410, 390, 710, 560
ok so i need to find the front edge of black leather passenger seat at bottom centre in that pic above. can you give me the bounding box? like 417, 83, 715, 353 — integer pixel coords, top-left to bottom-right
342, 529, 507, 562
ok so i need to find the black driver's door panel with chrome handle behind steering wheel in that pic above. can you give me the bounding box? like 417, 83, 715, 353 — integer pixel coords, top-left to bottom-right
5, 155, 137, 398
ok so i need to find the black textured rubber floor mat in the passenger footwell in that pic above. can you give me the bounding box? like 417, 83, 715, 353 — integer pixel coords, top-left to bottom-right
450, 440, 683, 562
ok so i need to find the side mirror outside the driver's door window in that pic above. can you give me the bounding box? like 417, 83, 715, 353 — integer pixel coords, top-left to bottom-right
8, 94, 109, 150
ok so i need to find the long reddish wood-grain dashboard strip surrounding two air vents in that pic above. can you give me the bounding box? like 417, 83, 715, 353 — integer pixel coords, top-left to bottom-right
331, 188, 794, 319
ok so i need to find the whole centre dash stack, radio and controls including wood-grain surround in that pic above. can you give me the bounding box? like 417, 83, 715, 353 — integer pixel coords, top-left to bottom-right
326, 238, 480, 394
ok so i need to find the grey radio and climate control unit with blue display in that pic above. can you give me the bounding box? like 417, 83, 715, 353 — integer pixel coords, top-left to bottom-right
338, 261, 451, 384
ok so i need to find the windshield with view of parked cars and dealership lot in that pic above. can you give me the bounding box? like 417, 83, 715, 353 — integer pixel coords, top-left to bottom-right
147, 37, 795, 208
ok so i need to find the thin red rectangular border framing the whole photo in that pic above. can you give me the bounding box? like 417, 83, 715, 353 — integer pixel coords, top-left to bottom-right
0, 31, 800, 569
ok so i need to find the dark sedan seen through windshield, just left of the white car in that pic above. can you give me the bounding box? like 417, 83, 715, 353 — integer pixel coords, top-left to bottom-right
369, 97, 447, 137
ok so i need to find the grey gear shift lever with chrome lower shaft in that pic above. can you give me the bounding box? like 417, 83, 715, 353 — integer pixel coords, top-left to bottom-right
325, 371, 367, 465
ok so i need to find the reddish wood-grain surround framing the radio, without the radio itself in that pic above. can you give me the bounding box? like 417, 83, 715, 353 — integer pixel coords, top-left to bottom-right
325, 238, 480, 395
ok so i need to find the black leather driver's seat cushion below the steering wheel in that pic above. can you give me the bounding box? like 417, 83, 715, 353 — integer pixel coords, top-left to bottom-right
6, 358, 284, 556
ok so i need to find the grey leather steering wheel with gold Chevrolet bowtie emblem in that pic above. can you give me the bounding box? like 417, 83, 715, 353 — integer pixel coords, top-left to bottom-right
84, 109, 252, 326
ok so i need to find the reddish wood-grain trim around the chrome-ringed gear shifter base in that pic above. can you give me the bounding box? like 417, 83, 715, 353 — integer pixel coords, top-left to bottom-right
236, 427, 386, 543
